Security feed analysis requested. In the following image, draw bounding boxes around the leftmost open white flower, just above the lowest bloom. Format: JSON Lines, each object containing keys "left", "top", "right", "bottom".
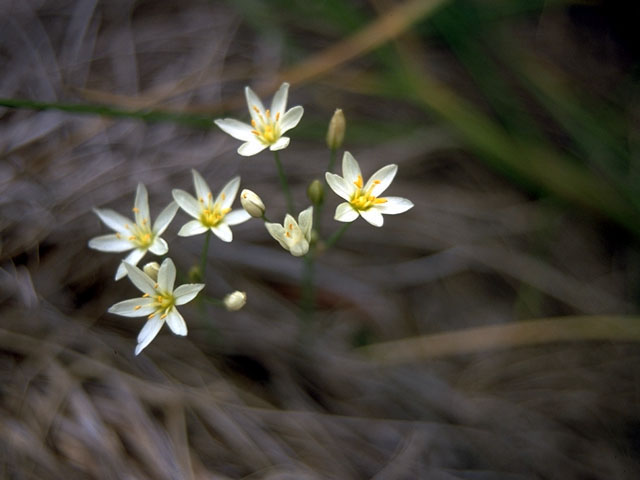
{"left": 89, "top": 183, "right": 178, "bottom": 280}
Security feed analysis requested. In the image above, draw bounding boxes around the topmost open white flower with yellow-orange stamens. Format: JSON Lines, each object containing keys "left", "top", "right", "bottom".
{"left": 215, "top": 83, "right": 304, "bottom": 157}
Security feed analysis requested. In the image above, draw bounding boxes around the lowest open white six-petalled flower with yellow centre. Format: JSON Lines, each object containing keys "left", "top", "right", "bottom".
{"left": 108, "top": 258, "right": 204, "bottom": 355}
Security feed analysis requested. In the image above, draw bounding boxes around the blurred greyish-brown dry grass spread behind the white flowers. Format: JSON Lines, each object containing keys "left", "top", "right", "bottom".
{"left": 0, "top": 0, "right": 640, "bottom": 480}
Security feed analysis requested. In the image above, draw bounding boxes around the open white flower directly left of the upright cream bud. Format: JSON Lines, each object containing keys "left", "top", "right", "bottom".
{"left": 171, "top": 170, "right": 251, "bottom": 242}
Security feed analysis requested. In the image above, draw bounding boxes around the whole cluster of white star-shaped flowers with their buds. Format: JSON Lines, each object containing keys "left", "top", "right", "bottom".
{"left": 89, "top": 79, "right": 413, "bottom": 355}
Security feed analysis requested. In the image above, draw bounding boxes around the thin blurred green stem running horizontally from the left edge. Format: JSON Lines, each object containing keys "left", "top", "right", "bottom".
{"left": 0, "top": 98, "right": 214, "bottom": 128}
